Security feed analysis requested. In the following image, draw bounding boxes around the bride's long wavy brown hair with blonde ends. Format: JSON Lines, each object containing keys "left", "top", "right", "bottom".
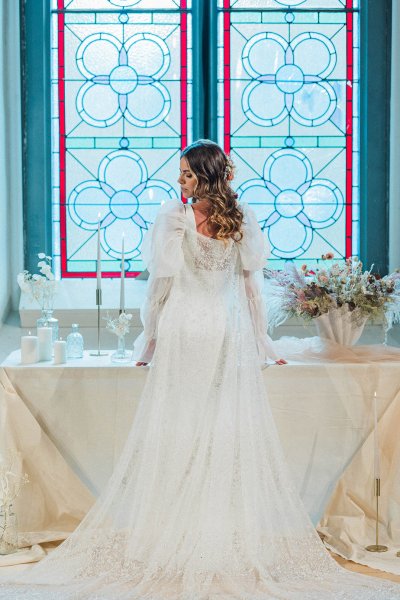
{"left": 181, "top": 140, "right": 243, "bottom": 241}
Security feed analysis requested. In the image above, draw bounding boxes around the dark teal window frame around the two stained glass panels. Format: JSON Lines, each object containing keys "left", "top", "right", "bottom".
{"left": 20, "top": 0, "right": 392, "bottom": 274}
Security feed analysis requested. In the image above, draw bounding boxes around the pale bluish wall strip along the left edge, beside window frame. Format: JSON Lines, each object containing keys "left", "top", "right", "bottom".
{"left": 0, "top": 0, "right": 23, "bottom": 323}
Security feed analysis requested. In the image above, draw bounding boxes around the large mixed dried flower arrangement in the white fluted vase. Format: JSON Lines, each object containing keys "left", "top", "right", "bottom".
{"left": 264, "top": 252, "right": 400, "bottom": 329}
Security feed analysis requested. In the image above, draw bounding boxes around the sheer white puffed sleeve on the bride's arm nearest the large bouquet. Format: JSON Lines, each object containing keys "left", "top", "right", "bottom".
{"left": 239, "top": 204, "right": 278, "bottom": 364}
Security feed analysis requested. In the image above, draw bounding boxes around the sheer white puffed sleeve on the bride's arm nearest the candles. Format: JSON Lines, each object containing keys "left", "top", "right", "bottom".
{"left": 133, "top": 200, "right": 185, "bottom": 363}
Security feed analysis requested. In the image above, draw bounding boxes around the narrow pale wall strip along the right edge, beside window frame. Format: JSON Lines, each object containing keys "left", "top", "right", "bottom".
{"left": 389, "top": 0, "right": 400, "bottom": 272}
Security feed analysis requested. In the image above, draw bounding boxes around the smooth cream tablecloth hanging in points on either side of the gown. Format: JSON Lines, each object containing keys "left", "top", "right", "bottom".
{"left": 2, "top": 344, "right": 400, "bottom": 572}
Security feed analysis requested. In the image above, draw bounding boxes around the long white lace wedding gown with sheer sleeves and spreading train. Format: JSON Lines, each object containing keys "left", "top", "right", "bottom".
{"left": 0, "top": 201, "right": 400, "bottom": 600}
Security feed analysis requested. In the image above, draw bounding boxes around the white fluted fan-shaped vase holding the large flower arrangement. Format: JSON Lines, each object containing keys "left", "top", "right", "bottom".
{"left": 314, "top": 304, "right": 368, "bottom": 346}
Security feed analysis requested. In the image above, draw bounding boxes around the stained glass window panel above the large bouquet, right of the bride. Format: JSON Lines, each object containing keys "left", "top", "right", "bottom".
{"left": 218, "top": 0, "right": 360, "bottom": 267}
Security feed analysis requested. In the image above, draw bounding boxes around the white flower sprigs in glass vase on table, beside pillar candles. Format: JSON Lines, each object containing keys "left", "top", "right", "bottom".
{"left": 17, "top": 252, "right": 57, "bottom": 308}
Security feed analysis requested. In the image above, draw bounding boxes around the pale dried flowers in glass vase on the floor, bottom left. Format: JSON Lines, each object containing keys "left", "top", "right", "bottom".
{"left": 0, "top": 451, "right": 29, "bottom": 554}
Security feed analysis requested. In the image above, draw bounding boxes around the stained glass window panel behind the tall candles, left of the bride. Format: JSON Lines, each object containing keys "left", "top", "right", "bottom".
{"left": 51, "top": 0, "right": 192, "bottom": 277}
